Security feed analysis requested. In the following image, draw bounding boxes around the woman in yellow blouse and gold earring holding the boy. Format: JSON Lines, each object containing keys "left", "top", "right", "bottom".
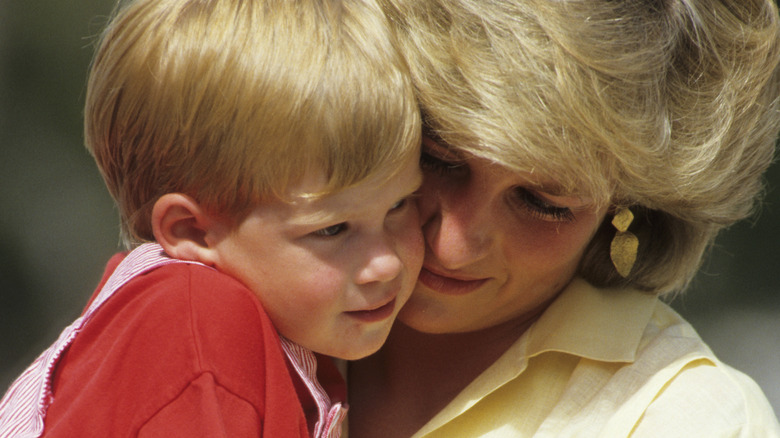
{"left": 349, "top": 0, "right": 780, "bottom": 438}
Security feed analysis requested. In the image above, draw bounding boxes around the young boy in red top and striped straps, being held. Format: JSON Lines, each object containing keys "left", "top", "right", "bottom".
{"left": 0, "top": 0, "right": 423, "bottom": 437}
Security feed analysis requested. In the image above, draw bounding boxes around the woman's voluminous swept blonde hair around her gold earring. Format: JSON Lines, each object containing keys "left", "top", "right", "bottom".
{"left": 383, "top": 0, "right": 780, "bottom": 293}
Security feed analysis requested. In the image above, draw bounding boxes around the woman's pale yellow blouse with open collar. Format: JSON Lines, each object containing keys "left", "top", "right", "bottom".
{"left": 414, "top": 280, "right": 780, "bottom": 438}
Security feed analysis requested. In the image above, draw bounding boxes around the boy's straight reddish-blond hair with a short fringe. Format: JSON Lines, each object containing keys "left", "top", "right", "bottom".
{"left": 85, "top": 0, "right": 420, "bottom": 243}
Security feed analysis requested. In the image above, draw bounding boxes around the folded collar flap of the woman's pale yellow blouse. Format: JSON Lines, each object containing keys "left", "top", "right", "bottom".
{"left": 526, "top": 278, "right": 657, "bottom": 362}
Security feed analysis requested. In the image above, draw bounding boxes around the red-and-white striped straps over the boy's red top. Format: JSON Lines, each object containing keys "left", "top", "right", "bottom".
{"left": 0, "top": 243, "right": 346, "bottom": 438}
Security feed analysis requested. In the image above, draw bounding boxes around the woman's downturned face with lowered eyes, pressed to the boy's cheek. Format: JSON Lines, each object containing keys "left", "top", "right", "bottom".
{"left": 399, "top": 137, "right": 606, "bottom": 333}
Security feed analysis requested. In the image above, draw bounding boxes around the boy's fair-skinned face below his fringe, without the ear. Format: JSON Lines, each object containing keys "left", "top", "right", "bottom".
{"left": 210, "top": 157, "right": 423, "bottom": 359}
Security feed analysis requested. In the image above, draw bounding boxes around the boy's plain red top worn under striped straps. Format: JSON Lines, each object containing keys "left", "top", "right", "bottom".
{"left": 39, "top": 252, "right": 332, "bottom": 438}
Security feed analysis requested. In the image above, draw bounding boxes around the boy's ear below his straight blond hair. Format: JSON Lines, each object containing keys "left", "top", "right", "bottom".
{"left": 152, "top": 193, "right": 224, "bottom": 266}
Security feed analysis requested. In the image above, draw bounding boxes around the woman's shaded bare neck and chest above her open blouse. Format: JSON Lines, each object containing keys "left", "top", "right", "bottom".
{"left": 349, "top": 318, "right": 536, "bottom": 438}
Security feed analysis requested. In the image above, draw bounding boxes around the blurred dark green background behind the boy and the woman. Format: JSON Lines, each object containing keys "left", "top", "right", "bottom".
{"left": 0, "top": 0, "right": 780, "bottom": 414}
